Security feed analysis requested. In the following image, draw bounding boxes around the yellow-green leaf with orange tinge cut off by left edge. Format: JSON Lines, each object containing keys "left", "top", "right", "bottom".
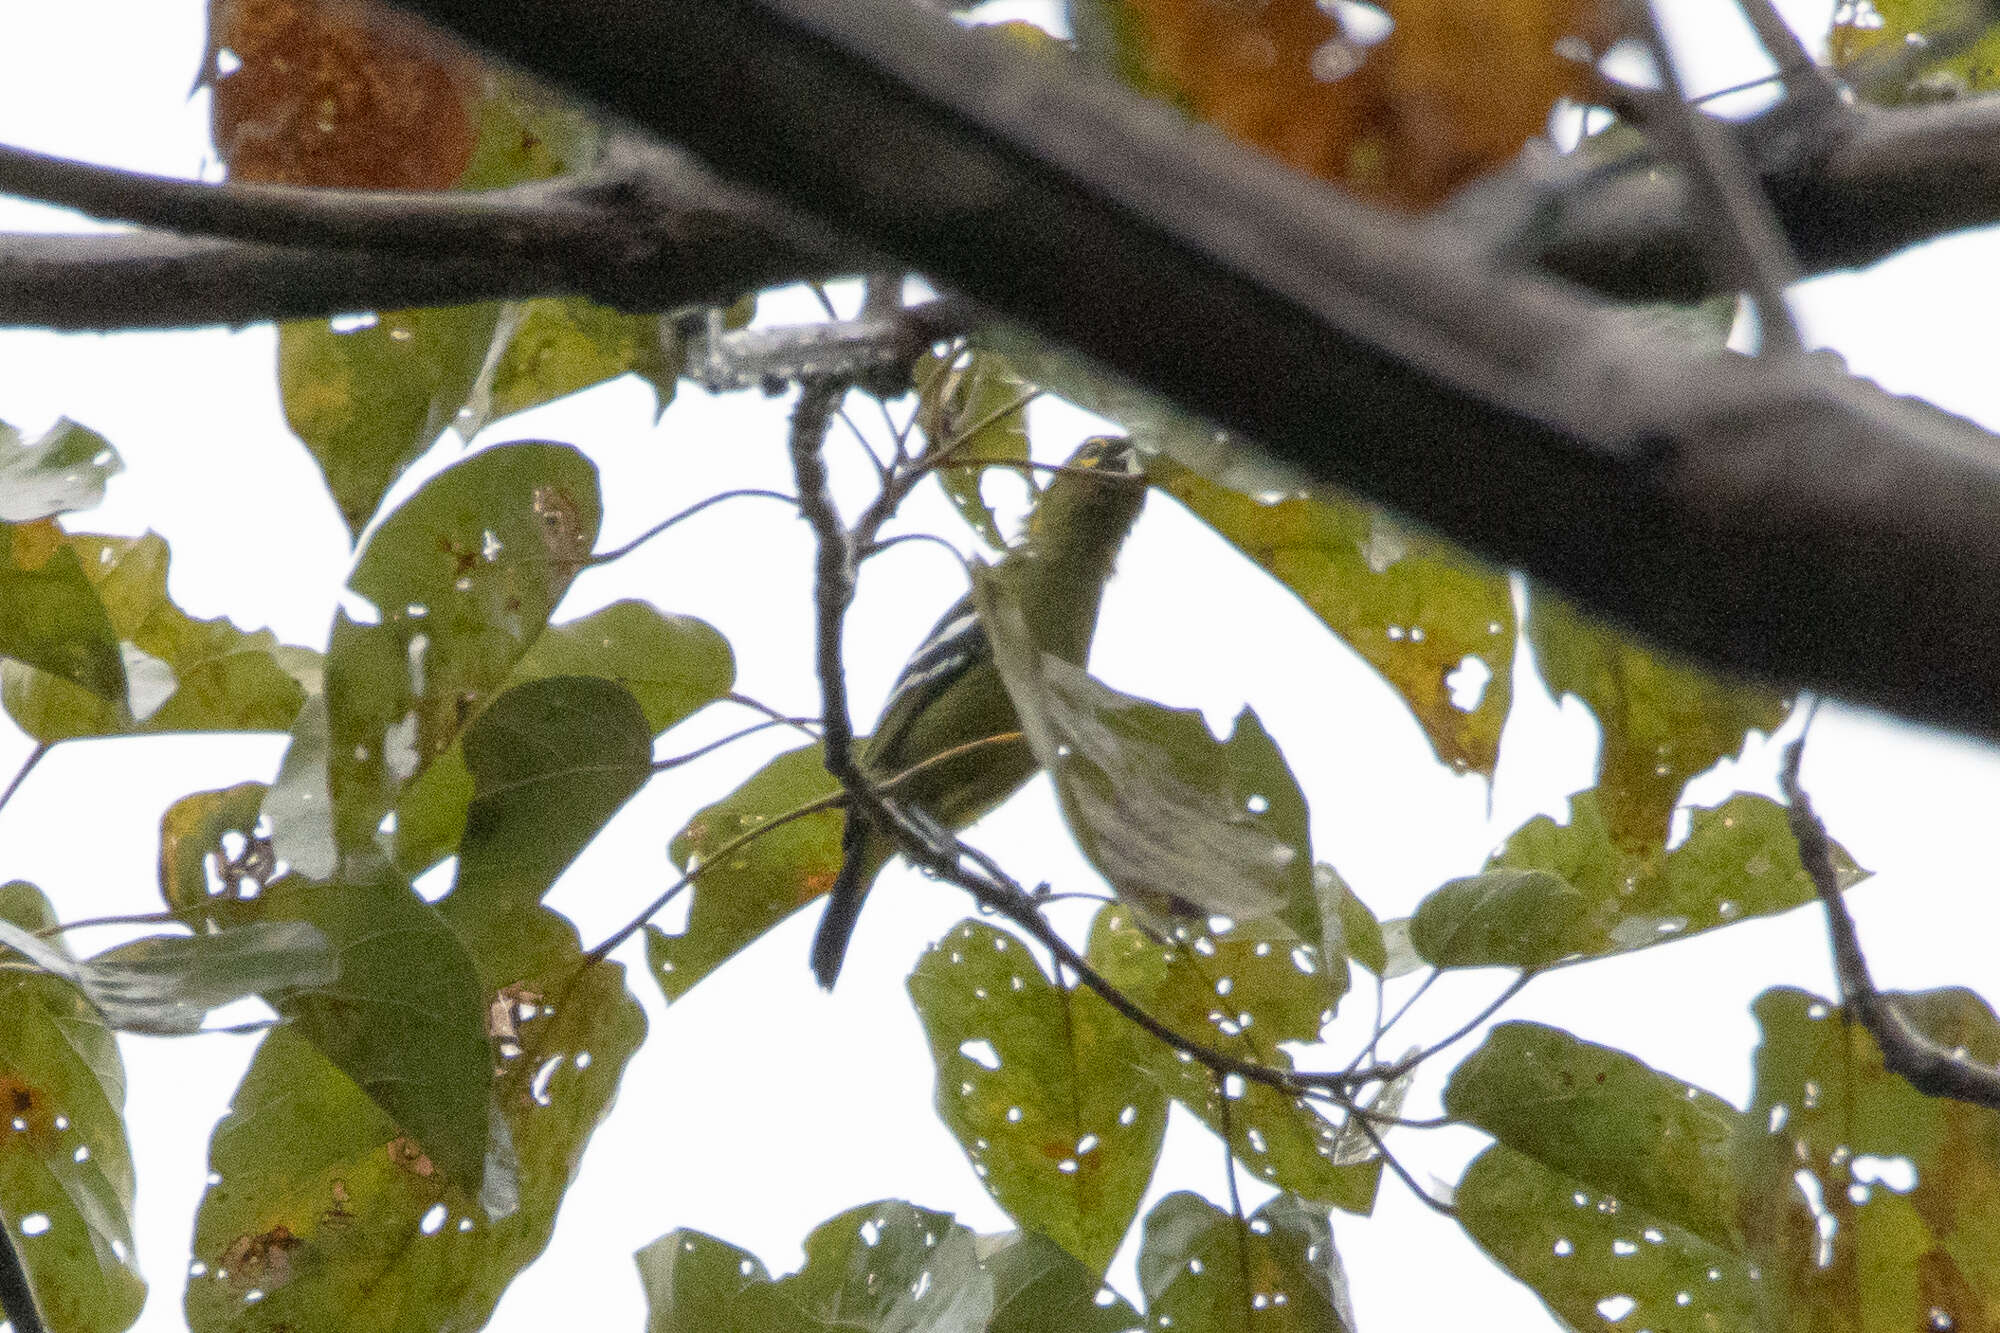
{"left": 0, "top": 522, "right": 126, "bottom": 713}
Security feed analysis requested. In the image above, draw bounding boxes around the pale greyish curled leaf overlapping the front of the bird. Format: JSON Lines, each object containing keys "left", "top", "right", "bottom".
{"left": 972, "top": 568, "right": 1288, "bottom": 924}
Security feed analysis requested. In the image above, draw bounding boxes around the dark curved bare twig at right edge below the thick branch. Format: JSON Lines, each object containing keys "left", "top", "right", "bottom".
{"left": 1778, "top": 737, "right": 2000, "bottom": 1109}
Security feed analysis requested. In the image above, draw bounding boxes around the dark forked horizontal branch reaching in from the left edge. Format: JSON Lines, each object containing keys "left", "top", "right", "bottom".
{"left": 0, "top": 140, "right": 852, "bottom": 330}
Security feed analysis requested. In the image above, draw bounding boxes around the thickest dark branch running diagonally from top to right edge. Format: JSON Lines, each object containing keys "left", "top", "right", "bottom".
{"left": 364, "top": 0, "right": 2000, "bottom": 748}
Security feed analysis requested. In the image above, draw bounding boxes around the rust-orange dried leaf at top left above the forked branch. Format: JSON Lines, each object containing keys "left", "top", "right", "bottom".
{"left": 208, "top": 0, "right": 478, "bottom": 190}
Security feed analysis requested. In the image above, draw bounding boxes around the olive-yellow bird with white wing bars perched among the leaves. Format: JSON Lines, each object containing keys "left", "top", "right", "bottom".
{"left": 812, "top": 436, "right": 1146, "bottom": 991}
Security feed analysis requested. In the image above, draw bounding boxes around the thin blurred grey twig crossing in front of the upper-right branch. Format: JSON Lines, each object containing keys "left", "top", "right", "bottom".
{"left": 1628, "top": 0, "right": 1804, "bottom": 354}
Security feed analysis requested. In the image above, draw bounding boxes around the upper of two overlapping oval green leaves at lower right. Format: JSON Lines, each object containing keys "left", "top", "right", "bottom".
{"left": 1444, "top": 1023, "right": 1744, "bottom": 1247}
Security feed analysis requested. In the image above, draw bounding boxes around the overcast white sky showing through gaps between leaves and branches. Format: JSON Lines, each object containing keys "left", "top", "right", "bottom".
{"left": 19, "top": 0, "right": 2000, "bottom": 1331}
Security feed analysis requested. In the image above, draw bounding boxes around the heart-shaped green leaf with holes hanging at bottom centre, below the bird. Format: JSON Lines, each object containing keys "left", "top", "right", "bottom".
{"left": 910, "top": 921, "right": 1166, "bottom": 1264}
